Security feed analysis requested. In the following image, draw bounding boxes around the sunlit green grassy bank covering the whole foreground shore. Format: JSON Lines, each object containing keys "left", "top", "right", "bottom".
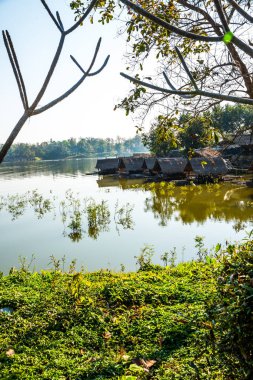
{"left": 0, "top": 239, "right": 253, "bottom": 380}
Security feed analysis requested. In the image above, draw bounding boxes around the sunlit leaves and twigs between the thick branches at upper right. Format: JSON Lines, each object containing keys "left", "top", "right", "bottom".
{"left": 67, "top": 0, "right": 251, "bottom": 126}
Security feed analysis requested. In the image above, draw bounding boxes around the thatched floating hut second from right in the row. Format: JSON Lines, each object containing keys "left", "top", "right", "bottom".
{"left": 153, "top": 157, "right": 188, "bottom": 178}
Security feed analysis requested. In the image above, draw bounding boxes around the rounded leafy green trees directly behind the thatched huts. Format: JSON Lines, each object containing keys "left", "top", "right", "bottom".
{"left": 142, "top": 104, "right": 253, "bottom": 156}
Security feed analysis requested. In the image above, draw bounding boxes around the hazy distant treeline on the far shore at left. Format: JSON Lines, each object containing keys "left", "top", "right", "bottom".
{"left": 1, "top": 136, "right": 147, "bottom": 161}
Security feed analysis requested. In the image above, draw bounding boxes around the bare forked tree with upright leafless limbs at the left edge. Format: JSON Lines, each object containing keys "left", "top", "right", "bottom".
{"left": 0, "top": 0, "right": 109, "bottom": 163}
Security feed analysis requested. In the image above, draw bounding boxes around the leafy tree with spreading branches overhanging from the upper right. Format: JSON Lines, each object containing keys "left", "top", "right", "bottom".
{"left": 71, "top": 0, "right": 253, "bottom": 121}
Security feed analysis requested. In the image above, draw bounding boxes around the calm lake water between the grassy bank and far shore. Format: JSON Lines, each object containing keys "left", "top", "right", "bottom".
{"left": 0, "top": 159, "right": 253, "bottom": 273}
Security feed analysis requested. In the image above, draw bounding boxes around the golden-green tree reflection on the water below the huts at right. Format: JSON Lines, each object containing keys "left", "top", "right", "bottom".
{"left": 144, "top": 184, "right": 253, "bottom": 230}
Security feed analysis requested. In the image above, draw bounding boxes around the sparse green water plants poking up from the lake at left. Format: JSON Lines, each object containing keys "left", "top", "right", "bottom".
{"left": 0, "top": 190, "right": 134, "bottom": 242}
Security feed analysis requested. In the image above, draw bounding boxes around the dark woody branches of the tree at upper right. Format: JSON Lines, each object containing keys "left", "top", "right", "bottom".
{"left": 120, "top": 0, "right": 253, "bottom": 116}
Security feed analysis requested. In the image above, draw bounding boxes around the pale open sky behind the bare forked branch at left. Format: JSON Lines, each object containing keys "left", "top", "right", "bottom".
{"left": 0, "top": 0, "right": 138, "bottom": 143}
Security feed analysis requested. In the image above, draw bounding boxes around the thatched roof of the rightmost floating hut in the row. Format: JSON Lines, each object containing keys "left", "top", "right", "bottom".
{"left": 190, "top": 157, "right": 228, "bottom": 175}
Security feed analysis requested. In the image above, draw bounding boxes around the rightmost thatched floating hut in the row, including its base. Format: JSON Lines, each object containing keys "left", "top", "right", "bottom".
{"left": 186, "top": 157, "right": 228, "bottom": 180}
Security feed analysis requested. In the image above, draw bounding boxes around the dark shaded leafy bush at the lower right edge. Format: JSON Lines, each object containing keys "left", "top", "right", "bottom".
{"left": 209, "top": 233, "right": 253, "bottom": 379}
